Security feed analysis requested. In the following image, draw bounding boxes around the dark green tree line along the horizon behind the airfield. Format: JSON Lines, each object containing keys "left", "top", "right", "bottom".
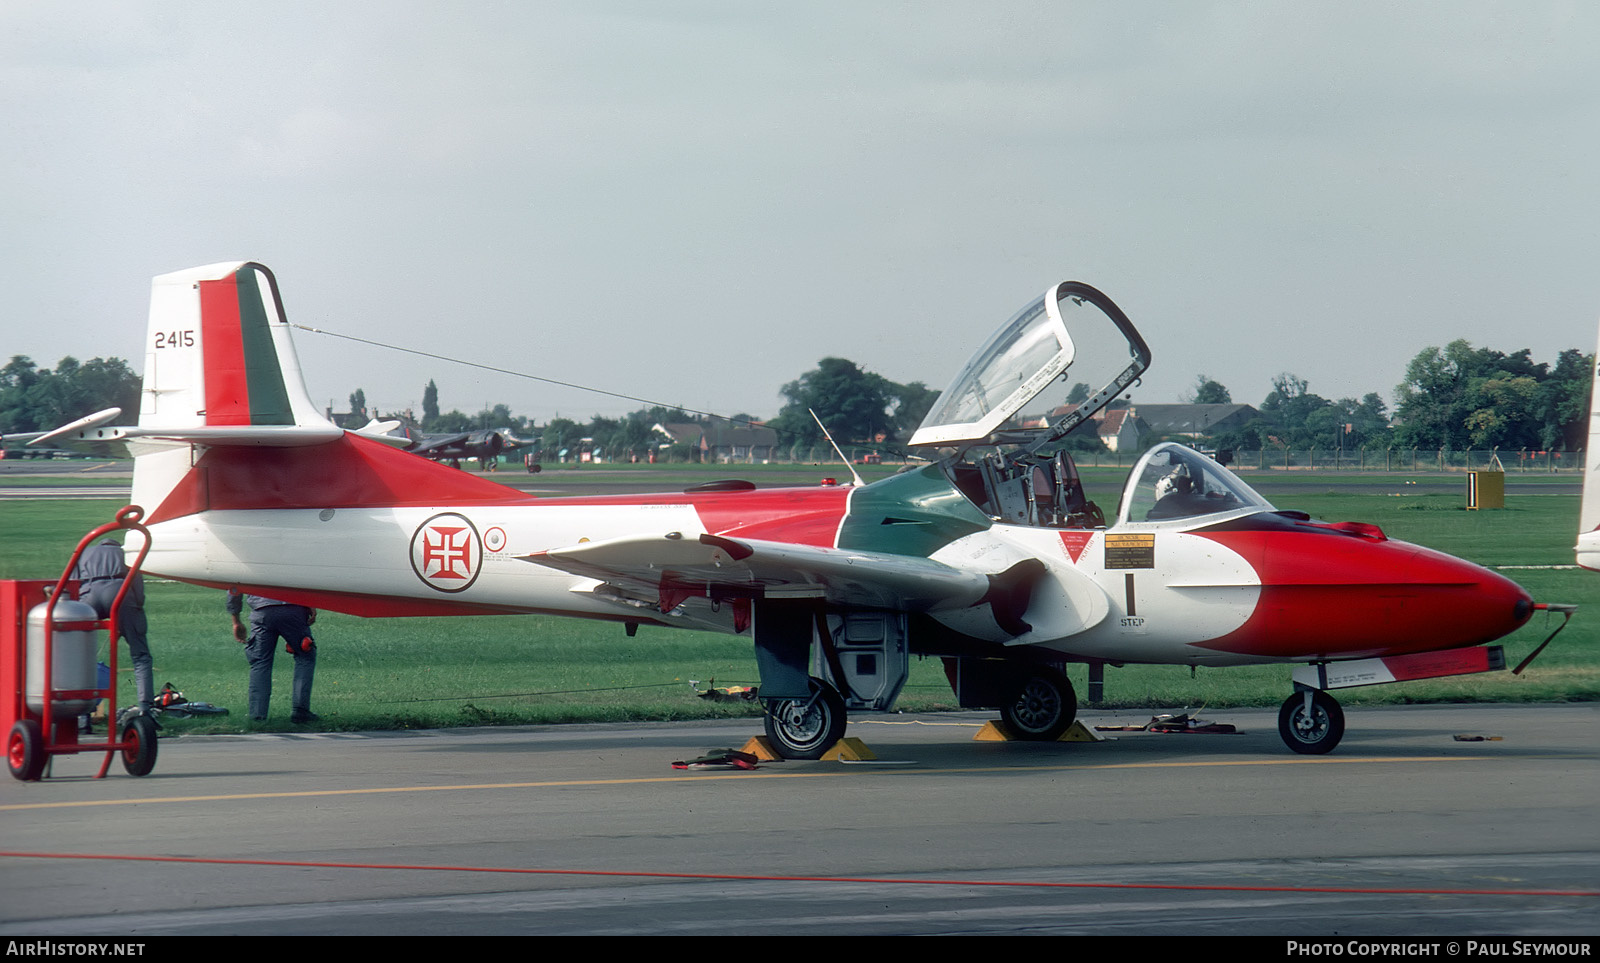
{"left": 0, "top": 339, "right": 1595, "bottom": 454}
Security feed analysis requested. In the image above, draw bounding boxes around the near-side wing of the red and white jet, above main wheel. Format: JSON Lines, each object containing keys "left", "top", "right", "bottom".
{"left": 522, "top": 533, "right": 998, "bottom": 611}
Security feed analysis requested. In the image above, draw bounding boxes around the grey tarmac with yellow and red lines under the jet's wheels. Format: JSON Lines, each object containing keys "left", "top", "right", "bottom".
{"left": 0, "top": 704, "right": 1600, "bottom": 937}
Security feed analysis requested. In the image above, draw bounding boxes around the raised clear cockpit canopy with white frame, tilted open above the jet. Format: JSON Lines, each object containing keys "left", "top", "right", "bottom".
{"left": 910, "top": 282, "right": 1150, "bottom": 451}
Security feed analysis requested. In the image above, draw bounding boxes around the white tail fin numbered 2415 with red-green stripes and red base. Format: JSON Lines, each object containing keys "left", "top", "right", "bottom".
{"left": 129, "top": 261, "right": 525, "bottom": 531}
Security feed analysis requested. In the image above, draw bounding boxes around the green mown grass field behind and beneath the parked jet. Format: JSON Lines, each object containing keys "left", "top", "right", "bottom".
{"left": 0, "top": 476, "right": 1600, "bottom": 733}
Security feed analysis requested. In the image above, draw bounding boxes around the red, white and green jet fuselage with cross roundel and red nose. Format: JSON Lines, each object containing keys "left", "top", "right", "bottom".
{"left": 146, "top": 437, "right": 1531, "bottom": 665}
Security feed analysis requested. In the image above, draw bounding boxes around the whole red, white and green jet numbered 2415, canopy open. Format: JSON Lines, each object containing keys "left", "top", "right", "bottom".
{"left": 65, "top": 262, "right": 1534, "bottom": 758}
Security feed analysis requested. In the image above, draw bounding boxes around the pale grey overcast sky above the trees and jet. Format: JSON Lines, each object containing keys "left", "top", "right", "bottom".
{"left": 0, "top": 0, "right": 1600, "bottom": 427}
